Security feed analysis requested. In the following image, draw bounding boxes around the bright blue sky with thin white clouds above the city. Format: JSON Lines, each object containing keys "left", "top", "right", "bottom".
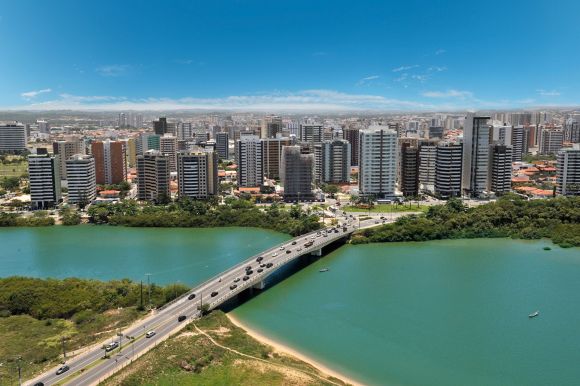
{"left": 0, "top": 0, "right": 580, "bottom": 111}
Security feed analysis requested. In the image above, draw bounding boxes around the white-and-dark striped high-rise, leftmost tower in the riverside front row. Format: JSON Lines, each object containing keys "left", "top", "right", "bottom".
{"left": 28, "top": 154, "right": 62, "bottom": 209}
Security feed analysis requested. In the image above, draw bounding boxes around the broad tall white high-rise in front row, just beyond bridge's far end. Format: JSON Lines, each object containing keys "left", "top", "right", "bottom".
{"left": 358, "top": 126, "right": 397, "bottom": 199}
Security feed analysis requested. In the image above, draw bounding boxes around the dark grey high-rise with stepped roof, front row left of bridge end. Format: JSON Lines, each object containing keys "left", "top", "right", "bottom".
{"left": 280, "top": 146, "right": 314, "bottom": 202}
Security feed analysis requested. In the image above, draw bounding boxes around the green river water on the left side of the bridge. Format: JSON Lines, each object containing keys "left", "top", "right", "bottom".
{"left": 0, "top": 225, "right": 290, "bottom": 285}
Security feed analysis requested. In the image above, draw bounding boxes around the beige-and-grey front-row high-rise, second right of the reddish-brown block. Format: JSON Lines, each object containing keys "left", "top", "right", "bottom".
{"left": 177, "top": 148, "right": 218, "bottom": 199}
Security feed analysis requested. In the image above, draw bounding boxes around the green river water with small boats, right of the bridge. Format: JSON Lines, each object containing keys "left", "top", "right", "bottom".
{"left": 233, "top": 240, "right": 580, "bottom": 386}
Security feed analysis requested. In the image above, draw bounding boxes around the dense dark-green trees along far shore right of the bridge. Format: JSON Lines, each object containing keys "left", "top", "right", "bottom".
{"left": 351, "top": 194, "right": 580, "bottom": 248}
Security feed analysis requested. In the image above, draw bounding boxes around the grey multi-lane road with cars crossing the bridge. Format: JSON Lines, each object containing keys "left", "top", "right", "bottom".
{"left": 25, "top": 214, "right": 390, "bottom": 386}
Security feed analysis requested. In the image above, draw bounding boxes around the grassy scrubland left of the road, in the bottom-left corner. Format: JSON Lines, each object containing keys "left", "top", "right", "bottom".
{"left": 0, "top": 308, "right": 141, "bottom": 386}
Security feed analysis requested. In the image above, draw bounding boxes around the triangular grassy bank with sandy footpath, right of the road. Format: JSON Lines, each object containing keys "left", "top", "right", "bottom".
{"left": 103, "top": 311, "right": 343, "bottom": 386}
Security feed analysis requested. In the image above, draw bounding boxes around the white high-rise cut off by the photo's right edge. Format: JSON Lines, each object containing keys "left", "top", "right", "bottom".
{"left": 556, "top": 144, "right": 580, "bottom": 196}
